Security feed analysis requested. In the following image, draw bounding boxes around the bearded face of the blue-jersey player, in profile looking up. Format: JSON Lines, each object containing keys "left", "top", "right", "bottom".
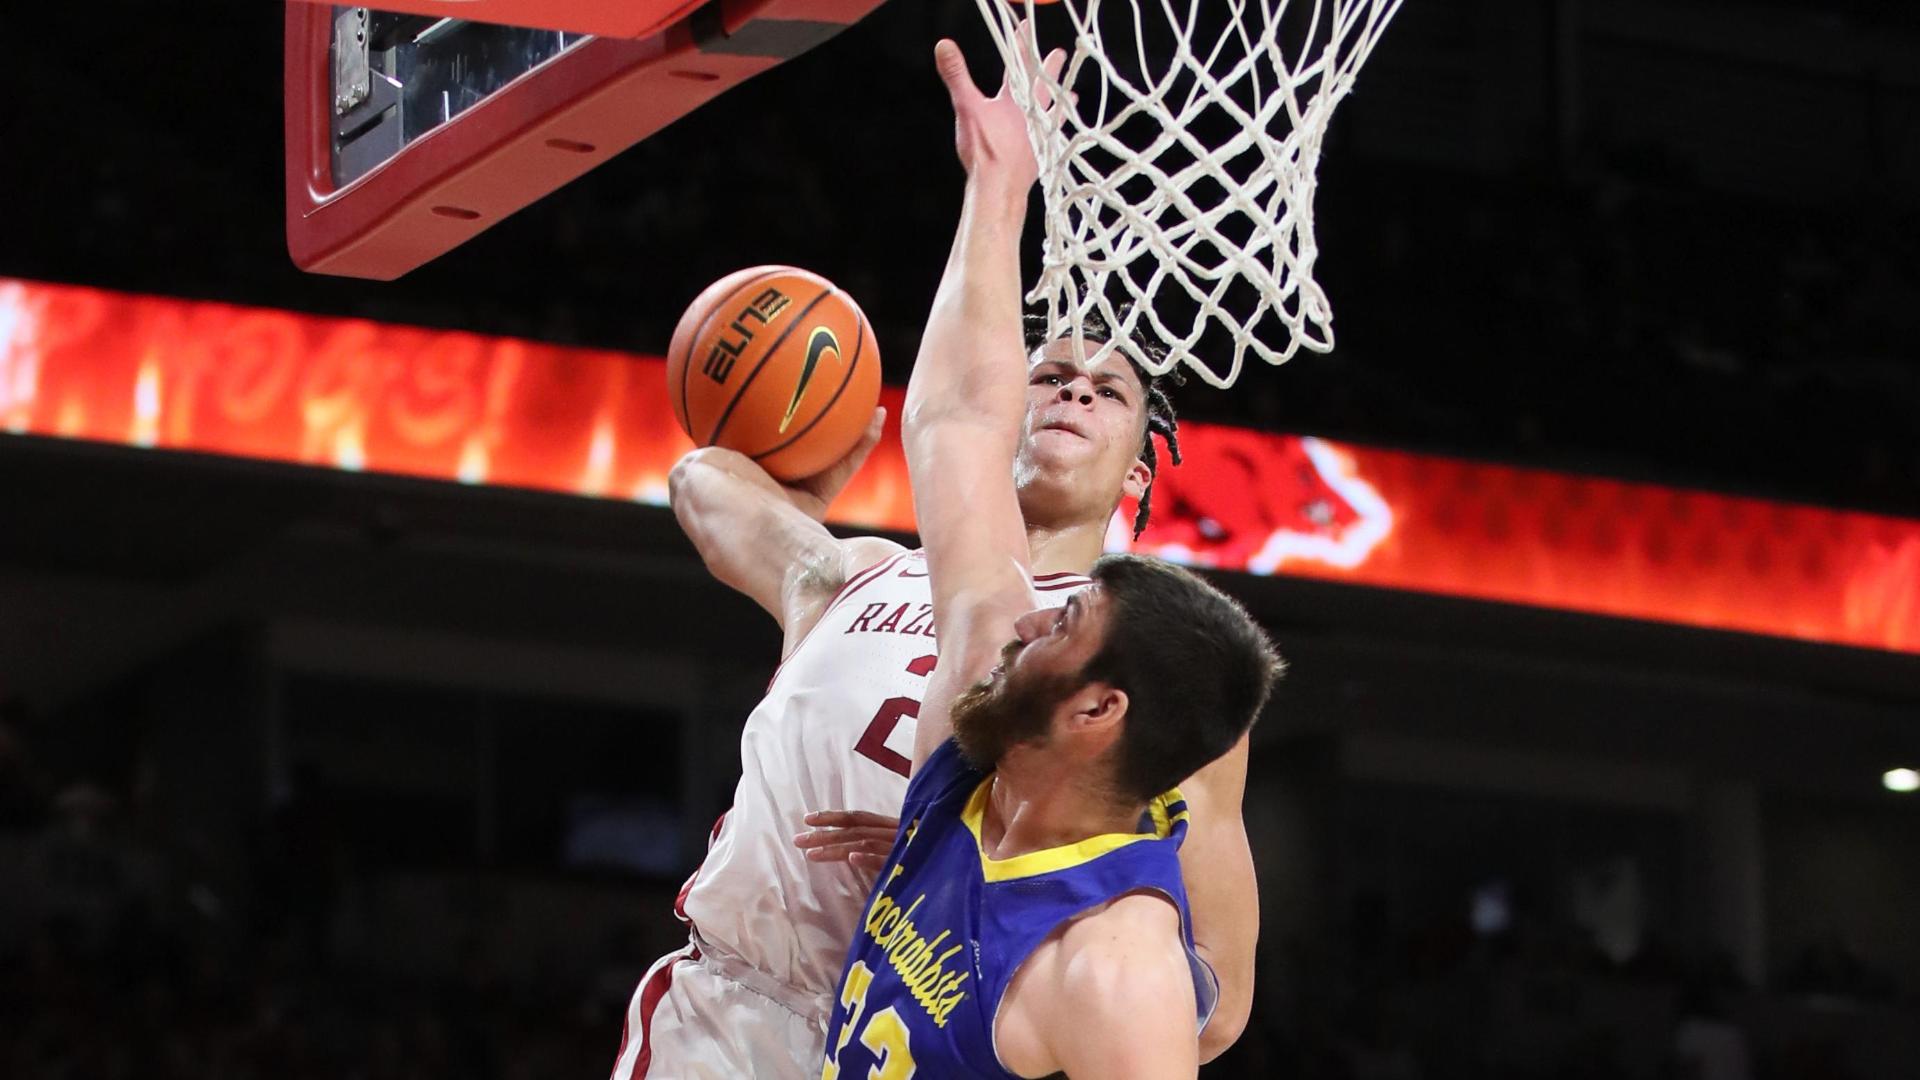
{"left": 952, "top": 584, "right": 1106, "bottom": 769}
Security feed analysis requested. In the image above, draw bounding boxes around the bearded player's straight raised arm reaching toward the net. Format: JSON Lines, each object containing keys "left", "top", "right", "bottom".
{"left": 904, "top": 40, "right": 1058, "bottom": 765}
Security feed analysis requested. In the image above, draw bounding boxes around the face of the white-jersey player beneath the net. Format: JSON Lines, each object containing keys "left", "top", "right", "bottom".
{"left": 1014, "top": 340, "right": 1146, "bottom": 521}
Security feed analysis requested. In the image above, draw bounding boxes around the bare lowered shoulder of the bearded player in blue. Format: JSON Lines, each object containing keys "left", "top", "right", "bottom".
{"left": 1029, "top": 894, "right": 1200, "bottom": 1080}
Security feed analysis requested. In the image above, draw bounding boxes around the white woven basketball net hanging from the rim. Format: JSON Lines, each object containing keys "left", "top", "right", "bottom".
{"left": 977, "top": 0, "right": 1400, "bottom": 388}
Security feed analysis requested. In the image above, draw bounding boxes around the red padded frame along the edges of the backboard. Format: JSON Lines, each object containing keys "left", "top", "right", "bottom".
{"left": 284, "top": 0, "right": 883, "bottom": 281}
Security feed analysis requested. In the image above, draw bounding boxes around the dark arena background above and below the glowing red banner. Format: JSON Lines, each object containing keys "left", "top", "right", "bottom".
{"left": 0, "top": 0, "right": 1920, "bottom": 1080}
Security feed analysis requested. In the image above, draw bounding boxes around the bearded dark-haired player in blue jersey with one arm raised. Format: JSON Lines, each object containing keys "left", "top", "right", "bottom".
{"left": 824, "top": 42, "right": 1281, "bottom": 1080}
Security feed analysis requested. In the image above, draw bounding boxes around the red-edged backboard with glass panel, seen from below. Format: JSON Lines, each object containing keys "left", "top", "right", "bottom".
{"left": 284, "top": 0, "right": 883, "bottom": 281}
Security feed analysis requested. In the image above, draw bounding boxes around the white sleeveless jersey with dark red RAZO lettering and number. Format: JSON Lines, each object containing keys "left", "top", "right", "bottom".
{"left": 678, "top": 552, "right": 1089, "bottom": 1024}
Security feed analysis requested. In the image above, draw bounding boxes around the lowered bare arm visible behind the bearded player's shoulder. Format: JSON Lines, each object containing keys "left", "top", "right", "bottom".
{"left": 1181, "top": 736, "right": 1260, "bottom": 1061}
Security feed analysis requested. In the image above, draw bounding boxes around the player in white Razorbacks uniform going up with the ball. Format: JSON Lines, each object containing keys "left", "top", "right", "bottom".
{"left": 612, "top": 46, "right": 1258, "bottom": 1080}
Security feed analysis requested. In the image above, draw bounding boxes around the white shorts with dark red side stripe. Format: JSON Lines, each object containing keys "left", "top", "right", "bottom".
{"left": 612, "top": 944, "right": 828, "bottom": 1080}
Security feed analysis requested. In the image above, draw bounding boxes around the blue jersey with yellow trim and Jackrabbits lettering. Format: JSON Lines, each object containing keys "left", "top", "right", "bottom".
{"left": 822, "top": 740, "right": 1219, "bottom": 1080}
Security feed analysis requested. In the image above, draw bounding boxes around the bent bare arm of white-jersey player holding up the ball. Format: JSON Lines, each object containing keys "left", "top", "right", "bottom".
{"left": 668, "top": 409, "right": 899, "bottom": 653}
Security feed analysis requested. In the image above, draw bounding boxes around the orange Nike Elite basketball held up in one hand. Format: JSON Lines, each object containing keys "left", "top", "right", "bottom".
{"left": 666, "top": 267, "right": 879, "bottom": 480}
